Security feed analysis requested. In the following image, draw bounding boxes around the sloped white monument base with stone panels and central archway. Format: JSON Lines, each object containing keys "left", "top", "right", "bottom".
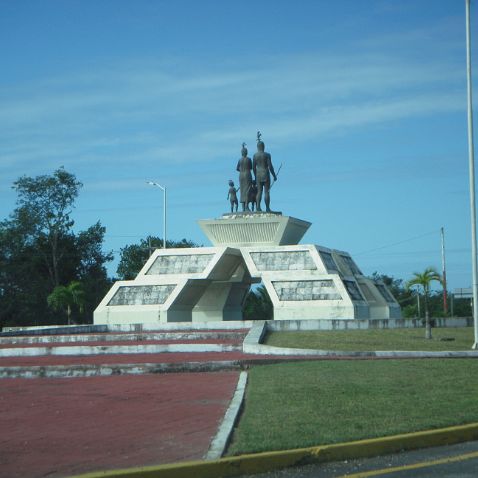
{"left": 94, "top": 245, "right": 401, "bottom": 324}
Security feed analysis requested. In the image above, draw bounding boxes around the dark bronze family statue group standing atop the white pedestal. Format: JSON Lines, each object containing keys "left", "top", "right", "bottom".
{"left": 227, "top": 131, "right": 277, "bottom": 213}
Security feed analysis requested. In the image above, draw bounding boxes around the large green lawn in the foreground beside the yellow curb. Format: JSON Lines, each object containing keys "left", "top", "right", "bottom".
{"left": 228, "top": 359, "right": 478, "bottom": 455}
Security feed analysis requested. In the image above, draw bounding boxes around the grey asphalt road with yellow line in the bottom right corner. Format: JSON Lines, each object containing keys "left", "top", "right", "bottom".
{"left": 242, "top": 441, "right": 478, "bottom": 478}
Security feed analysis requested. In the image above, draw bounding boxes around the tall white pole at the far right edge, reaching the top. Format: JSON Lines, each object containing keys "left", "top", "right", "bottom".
{"left": 465, "top": 0, "right": 478, "bottom": 349}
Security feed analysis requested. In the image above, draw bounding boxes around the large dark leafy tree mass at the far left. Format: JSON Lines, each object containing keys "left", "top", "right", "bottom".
{"left": 0, "top": 168, "right": 112, "bottom": 326}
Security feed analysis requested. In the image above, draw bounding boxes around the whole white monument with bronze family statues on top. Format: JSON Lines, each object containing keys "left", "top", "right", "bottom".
{"left": 94, "top": 132, "right": 401, "bottom": 324}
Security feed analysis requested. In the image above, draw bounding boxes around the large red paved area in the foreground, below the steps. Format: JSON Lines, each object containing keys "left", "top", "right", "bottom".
{"left": 0, "top": 372, "right": 239, "bottom": 478}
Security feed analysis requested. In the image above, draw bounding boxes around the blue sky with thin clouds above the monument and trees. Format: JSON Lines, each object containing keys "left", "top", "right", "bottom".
{"left": 0, "top": 0, "right": 478, "bottom": 288}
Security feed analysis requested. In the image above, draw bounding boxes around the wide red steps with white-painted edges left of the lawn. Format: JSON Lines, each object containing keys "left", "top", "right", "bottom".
{"left": 0, "top": 324, "right": 258, "bottom": 378}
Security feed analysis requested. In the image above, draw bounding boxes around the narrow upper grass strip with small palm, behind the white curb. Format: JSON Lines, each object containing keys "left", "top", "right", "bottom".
{"left": 265, "top": 327, "right": 474, "bottom": 351}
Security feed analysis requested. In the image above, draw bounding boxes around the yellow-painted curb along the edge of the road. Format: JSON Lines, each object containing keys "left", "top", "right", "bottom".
{"left": 70, "top": 423, "right": 478, "bottom": 478}
